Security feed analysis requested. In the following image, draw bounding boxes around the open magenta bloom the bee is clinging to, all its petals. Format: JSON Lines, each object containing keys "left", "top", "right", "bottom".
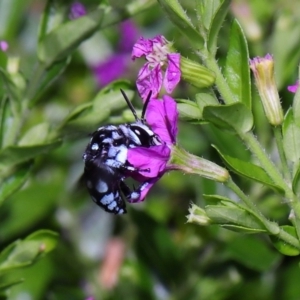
{"left": 127, "top": 95, "right": 178, "bottom": 202}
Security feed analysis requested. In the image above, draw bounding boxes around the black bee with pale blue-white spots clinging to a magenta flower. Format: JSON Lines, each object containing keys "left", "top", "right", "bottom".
{"left": 83, "top": 90, "right": 162, "bottom": 214}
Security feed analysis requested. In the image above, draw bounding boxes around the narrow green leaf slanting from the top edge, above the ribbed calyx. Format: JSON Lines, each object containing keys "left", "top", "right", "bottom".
{"left": 158, "top": 0, "right": 204, "bottom": 50}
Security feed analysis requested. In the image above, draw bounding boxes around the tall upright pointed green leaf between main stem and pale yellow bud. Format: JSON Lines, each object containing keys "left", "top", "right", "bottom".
{"left": 224, "top": 20, "right": 251, "bottom": 110}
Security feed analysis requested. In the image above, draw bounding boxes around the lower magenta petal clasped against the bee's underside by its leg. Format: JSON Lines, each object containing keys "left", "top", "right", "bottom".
{"left": 127, "top": 145, "right": 171, "bottom": 181}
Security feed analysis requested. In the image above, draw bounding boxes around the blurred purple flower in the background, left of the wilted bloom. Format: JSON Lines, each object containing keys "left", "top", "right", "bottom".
{"left": 92, "top": 20, "right": 138, "bottom": 86}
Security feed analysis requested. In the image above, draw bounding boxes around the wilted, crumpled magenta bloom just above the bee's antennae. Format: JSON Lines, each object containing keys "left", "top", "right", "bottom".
{"left": 132, "top": 35, "right": 181, "bottom": 101}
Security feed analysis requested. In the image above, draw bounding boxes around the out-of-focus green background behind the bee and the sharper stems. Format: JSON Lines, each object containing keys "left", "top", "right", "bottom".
{"left": 0, "top": 0, "right": 300, "bottom": 300}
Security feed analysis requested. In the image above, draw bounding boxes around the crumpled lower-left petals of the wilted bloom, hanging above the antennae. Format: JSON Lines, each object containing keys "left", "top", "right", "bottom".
{"left": 136, "top": 63, "right": 163, "bottom": 101}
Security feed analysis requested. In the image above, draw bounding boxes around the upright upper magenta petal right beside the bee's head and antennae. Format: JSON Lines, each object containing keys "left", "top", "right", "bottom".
{"left": 146, "top": 95, "right": 178, "bottom": 144}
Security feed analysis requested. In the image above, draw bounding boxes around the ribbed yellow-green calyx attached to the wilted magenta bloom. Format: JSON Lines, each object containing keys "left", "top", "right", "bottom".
{"left": 180, "top": 56, "right": 215, "bottom": 88}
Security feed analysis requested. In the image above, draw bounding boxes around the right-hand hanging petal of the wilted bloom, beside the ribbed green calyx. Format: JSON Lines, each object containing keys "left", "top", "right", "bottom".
{"left": 163, "top": 53, "right": 181, "bottom": 94}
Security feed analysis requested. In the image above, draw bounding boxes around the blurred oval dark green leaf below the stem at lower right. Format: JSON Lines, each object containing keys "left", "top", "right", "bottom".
{"left": 226, "top": 236, "right": 280, "bottom": 272}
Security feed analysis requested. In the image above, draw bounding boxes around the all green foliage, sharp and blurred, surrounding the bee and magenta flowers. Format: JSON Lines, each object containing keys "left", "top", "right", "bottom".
{"left": 0, "top": 0, "right": 300, "bottom": 300}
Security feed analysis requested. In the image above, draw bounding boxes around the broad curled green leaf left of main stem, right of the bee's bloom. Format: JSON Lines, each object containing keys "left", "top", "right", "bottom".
{"left": 203, "top": 102, "right": 253, "bottom": 133}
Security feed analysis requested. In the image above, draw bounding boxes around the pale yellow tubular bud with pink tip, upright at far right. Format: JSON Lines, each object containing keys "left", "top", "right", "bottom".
{"left": 250, "top": 54, "right": 283, "bottom": 126}
